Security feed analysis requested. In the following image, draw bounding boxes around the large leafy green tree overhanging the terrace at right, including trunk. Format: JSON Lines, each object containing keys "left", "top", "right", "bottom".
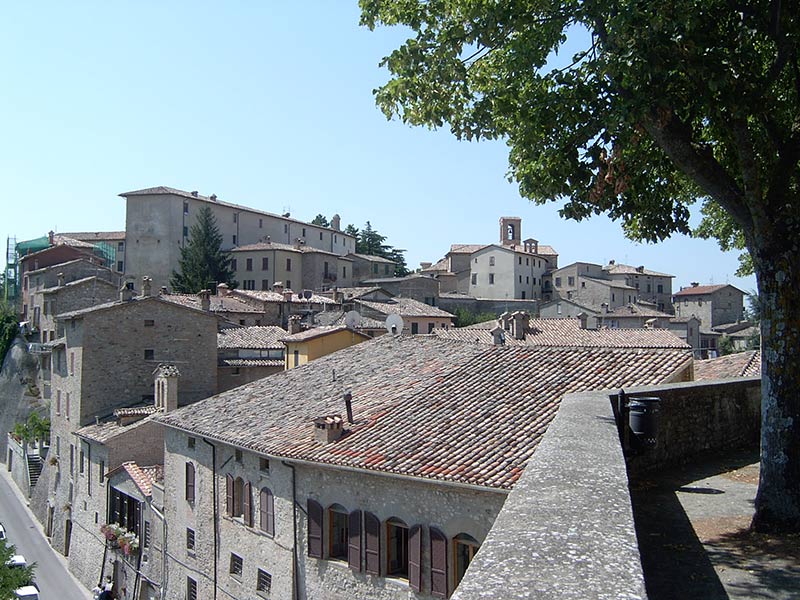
{"left": 360, "top": 0, "right": 800, "bottom": 531}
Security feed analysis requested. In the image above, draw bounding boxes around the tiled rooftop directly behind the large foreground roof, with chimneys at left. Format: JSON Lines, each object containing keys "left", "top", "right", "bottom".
{"left": 433, "top": 319, "right": 689, "bottom": 349}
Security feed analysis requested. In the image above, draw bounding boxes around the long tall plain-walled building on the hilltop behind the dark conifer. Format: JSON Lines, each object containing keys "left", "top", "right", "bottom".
{"left": 120, "top": 186, "right": 355, "bottom": 287}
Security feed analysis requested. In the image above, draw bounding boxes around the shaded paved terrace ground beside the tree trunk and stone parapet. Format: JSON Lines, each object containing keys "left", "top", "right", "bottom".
{"left": 631, "top": 450, "right": 800, "bottom": 600}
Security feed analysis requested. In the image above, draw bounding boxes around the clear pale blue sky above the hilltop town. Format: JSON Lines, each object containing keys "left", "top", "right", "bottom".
{"left": 0, "top": 0, "right": 755, "bottom": 291}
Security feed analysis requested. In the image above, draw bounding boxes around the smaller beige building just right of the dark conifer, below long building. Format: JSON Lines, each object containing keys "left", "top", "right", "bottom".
{"left": 231, "top": 238, "right": 353, "bottom": 292}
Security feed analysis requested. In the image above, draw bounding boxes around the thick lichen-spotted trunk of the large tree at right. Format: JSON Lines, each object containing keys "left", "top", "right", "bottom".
{"left": 752, "top": 241, "right": 800, "bottom": 533}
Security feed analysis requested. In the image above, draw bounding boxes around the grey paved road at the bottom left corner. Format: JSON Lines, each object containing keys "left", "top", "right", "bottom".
{"left": 0, "top": 464, "right": 92, "bottom": 600}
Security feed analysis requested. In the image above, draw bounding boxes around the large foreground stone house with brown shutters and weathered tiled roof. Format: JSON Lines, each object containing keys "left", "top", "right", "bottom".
{"left": 158, "top": 335, "right": 692, "bottom": 600}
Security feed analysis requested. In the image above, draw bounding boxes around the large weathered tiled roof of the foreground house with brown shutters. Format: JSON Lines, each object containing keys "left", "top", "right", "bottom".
{"left": 158, "top": 335, "right": 691, "bottom": 489}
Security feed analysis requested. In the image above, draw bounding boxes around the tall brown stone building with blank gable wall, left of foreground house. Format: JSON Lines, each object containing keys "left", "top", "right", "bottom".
{"left": 37, "top": 281, "right": 217, "bottom": 554}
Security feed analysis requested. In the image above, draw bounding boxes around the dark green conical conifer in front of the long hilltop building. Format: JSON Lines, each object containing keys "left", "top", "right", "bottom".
{"left": 170, "top": 206, "right": 236, "bottom": 294}
